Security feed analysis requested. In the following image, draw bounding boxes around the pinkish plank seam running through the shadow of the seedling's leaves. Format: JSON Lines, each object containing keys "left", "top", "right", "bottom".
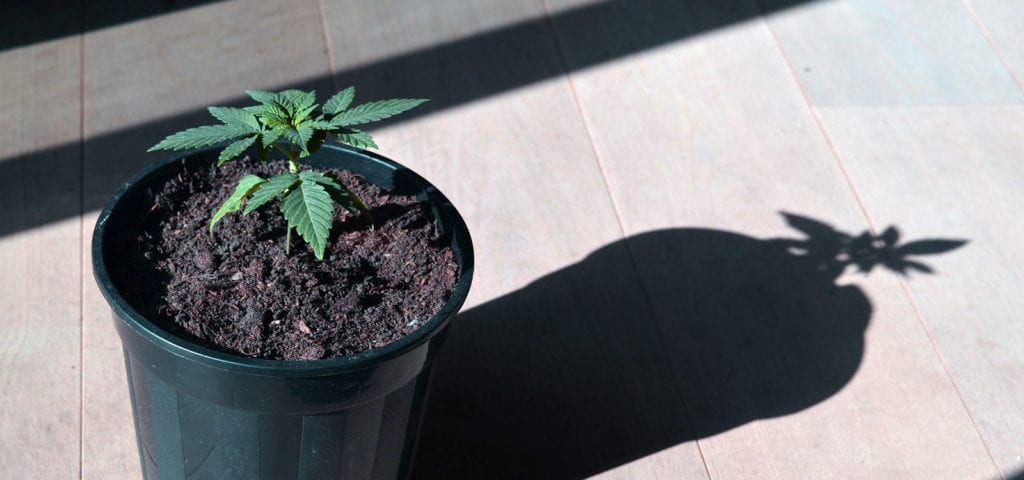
{"left": 755, "top": 1, "right": 1006, "bottom": 474}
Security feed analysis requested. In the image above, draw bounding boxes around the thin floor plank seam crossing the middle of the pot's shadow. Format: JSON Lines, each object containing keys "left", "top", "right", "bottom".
{"left": 541, "top": 0, "right": 712, "bottom": 480}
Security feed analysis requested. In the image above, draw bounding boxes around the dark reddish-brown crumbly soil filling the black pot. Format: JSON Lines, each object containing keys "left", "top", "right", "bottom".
{"left": 115, "top": 159, "right": 458, "bottom": 360}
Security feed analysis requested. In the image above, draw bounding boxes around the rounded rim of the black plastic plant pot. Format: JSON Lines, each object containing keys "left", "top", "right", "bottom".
{"left": 91, "top": 143, "right": 474, "bottom": 377}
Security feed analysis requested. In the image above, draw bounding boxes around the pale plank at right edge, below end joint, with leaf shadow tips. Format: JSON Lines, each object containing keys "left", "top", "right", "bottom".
{"left": 822, "top": 105, "right": 1024, "bottom": 474}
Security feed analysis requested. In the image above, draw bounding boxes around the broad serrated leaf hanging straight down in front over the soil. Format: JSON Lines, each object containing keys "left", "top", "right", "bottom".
{"left": 281, "top": 181, "right": 334, "bottom": 260}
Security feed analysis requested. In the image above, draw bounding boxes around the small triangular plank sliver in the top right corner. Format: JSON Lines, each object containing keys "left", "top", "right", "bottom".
{"left": 964, "top": 0, "right": 1024, "bottom": 88}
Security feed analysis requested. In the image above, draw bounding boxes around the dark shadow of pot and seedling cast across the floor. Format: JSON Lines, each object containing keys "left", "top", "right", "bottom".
{"left": 414, "top": 213, "right": 966, "bottom": 479}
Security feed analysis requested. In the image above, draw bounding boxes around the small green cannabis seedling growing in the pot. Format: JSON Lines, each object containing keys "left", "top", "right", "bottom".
{"left": 148, "top": 87, "right": 427, "bottom": 260}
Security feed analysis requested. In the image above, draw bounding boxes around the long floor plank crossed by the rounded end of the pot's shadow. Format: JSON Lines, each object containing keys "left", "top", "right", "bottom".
{"left": 555, "top": 2, "right": 995, "bottom": 472}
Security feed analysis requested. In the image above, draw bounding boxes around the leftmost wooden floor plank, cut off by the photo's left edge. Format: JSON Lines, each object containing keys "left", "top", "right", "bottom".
{"left": 0, "top": 38, "right": 82, "bottom": 478}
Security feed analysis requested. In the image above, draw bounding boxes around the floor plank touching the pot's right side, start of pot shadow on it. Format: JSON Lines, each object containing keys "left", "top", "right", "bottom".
{"left": 325, "top": 1, "right": 703, "bottom": 478}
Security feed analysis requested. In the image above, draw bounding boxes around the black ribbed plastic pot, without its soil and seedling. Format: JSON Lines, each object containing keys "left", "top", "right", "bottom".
{"left": 92, "top": 144, "right": 473, "bottom": 480}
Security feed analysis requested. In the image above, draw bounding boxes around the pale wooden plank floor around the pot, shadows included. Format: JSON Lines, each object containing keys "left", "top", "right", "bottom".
{"left": 0, "top": 0, "right": 1024, "bottom": 480}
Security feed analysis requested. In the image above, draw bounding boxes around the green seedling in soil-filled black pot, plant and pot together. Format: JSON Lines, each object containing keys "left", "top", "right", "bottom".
{"left": 92, "top": 87, "right": 473, "bottom": 479}
